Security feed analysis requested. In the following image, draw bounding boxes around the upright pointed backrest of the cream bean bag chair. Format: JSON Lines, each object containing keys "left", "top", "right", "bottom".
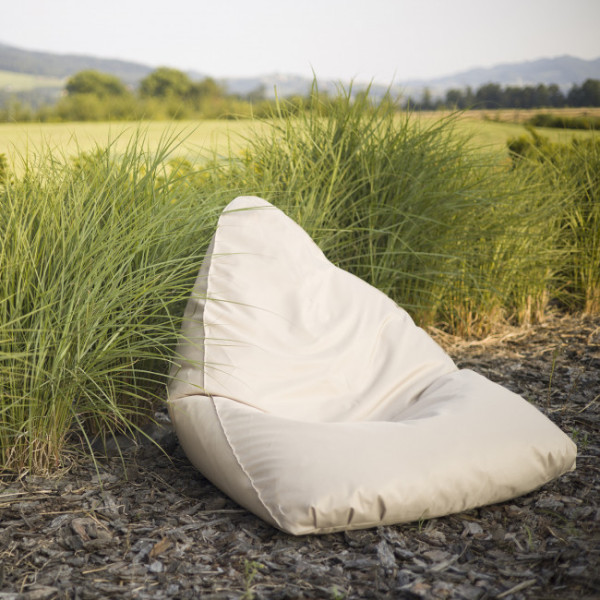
{"left": 170, "top": 197, "right": 456, "bottom": 421}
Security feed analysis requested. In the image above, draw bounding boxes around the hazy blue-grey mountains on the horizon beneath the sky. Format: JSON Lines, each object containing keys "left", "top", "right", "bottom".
{"left": 0, "top": 43, "right": 600, "bottom": 98}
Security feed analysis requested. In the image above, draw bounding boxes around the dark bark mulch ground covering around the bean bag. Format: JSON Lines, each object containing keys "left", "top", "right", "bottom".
{"left": 0, "top": 314, "right": 600, "bottom": 600}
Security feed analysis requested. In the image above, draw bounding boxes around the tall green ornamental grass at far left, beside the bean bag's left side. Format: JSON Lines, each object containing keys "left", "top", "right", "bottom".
{"left": 0, "top": 135, "right": 218, "bottom": 471}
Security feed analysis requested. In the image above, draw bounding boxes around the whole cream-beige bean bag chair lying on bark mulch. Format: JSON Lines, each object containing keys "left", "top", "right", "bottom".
{"left": 169, "top": 197, "right": 576, "bottom": 534}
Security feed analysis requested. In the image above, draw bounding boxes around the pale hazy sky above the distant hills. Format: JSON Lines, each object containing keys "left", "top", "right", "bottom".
{"left": 0, "top": 0, "right": 600, "bottom": 83}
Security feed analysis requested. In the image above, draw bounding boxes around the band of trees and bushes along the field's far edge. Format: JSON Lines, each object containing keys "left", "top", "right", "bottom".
{"left": 0, "top": 67, "right": 600, "bottom": 122}
